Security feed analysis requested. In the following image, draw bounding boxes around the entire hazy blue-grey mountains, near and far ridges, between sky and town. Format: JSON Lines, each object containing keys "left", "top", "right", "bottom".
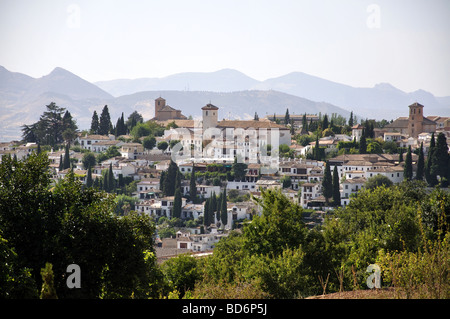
{"left": 0, "top": 66, "right": 450, "bottom": 141}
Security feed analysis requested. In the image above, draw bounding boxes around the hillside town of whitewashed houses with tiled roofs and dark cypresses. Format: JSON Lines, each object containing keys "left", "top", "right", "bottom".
{"left": 0, "top": 97, "right": 450, "bottom": 260}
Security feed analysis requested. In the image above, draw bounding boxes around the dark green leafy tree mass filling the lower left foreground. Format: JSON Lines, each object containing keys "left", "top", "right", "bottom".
{"left": 0, "top": 154, "right": 164, "bottom": 298}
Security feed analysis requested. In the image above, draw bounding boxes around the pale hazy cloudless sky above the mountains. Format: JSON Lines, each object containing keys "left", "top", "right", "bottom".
{"left": 0, "top": 0, "right": 450, "bottom": 96}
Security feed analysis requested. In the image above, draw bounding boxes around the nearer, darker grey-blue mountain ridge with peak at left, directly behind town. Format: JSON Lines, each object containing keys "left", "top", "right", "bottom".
{"left": 0, "top": 68, "right": 350, "bottom": 141}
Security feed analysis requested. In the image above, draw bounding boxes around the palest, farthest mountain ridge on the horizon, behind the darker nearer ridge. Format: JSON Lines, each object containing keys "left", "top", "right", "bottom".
{"left": 95, "top": 69, "right": 450, "bottom": 120}
